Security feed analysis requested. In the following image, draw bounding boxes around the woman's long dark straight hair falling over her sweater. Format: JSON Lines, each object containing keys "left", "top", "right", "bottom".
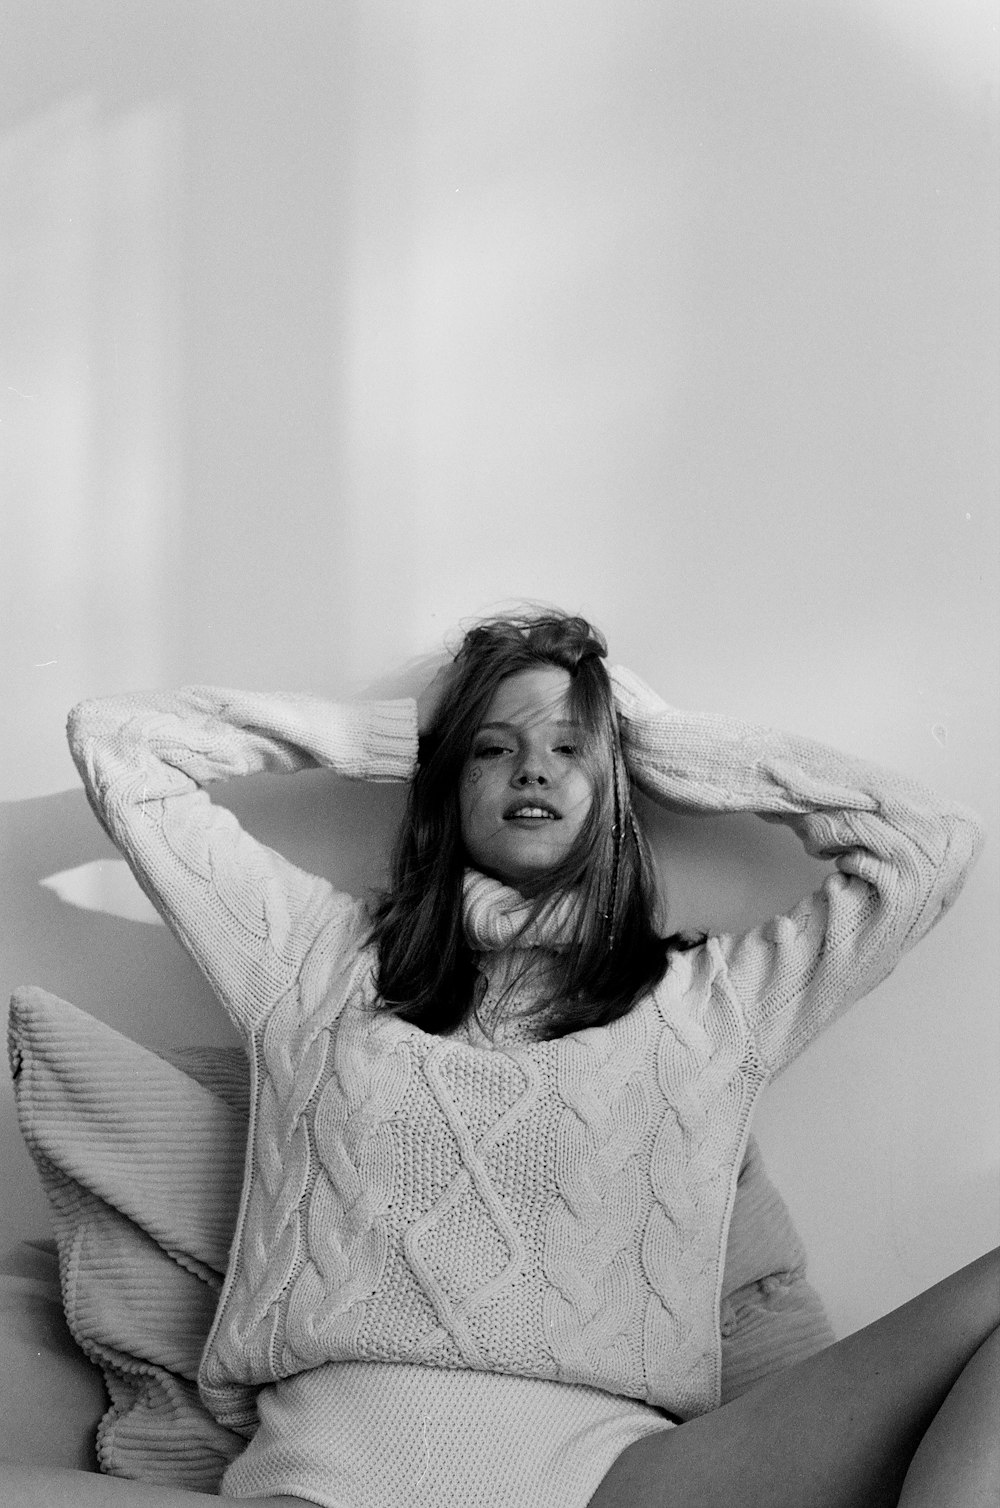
{"left": 371, "top": 612, "right": 685, "bottom": 1038}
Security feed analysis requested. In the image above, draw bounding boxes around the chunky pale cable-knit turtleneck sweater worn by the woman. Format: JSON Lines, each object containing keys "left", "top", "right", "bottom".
{"left": 69, "top": 670, "right": 977, "bottom": 1502}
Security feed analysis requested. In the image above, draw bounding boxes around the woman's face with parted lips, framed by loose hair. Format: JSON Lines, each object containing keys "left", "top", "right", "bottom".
{"left": 460, "top": 665, "right": 594, "bottom": 890}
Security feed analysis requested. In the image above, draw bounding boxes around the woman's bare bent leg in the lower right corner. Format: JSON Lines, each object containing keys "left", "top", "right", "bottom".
{"left": 590, "top": 1252, "right": 1000, "bottom": 1508}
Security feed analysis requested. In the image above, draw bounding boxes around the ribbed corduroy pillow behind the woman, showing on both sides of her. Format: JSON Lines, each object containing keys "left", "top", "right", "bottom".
{"left": 9, "top": 988, "right": 833, "bottom": 1493}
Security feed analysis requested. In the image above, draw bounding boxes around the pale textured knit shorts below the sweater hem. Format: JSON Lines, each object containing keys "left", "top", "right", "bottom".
{"left": 220, "top": 1362, "right": 671, "bottom": 1508}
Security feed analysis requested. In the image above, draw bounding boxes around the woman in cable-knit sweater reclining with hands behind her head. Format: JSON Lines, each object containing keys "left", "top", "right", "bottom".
{"left": 8, "top": 614, "right": 1000, "bottom": 1508}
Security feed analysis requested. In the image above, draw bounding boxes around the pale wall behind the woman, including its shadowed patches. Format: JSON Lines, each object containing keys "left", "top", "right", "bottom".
{"left": 0, "top": 0, "right": 1000, "bottom": 1332}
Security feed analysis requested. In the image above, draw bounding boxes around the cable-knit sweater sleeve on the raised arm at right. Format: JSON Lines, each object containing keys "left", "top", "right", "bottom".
{"left": 612, "top": 670, "right": 982, "bottom": 1072}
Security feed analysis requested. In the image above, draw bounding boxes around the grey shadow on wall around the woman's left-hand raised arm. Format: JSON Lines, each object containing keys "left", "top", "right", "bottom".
{"left": 0, "top": 771, "right": 403, "bottom": 1045}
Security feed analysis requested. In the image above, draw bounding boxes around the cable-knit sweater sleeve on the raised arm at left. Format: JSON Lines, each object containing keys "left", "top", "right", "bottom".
{"left": 68, "top": 688, "right": 416, "bottom": 1031}
